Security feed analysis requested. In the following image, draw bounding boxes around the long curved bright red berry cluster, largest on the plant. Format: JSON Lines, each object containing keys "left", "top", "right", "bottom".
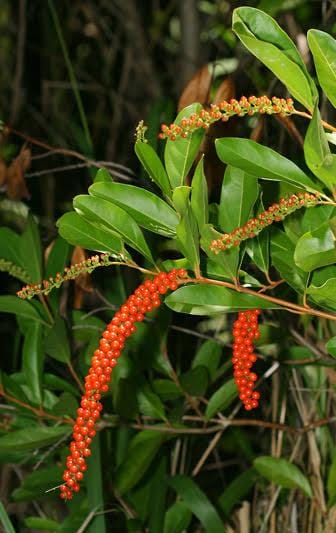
{"left": 60, "top": 269, "right": 186, "bottom": 500}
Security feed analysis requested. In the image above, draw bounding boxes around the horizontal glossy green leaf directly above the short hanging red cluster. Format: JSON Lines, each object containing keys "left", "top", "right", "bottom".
{"left": 165, "top": 285, "right": 279, "bottom": 315}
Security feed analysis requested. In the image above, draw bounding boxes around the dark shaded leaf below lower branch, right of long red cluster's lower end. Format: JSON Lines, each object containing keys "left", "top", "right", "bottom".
{"left": 115, "top": 431, "right": 166, "bottom": 494}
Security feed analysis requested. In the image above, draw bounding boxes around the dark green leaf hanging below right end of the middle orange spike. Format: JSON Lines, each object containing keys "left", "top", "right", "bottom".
{"left": 271, "top": 229, "right": 308, "bottom": 293}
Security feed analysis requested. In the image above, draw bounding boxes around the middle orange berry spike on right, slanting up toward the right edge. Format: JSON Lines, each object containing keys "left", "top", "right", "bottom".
{"left": 210, "top": 192, "right": 320, "bottom": 255}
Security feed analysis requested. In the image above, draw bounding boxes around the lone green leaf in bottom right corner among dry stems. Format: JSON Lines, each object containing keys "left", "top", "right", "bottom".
{"left": 253, "top": 455, "right": 313, "bottom": 498}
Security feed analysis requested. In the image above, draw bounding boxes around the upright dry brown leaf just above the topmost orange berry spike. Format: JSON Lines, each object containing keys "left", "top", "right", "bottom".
{"left": 177, "top": 64, "right": 212, "bottom": 111}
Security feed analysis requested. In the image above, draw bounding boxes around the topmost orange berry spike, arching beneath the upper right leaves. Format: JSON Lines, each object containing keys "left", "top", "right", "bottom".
{"left": 159, "top": 96, "right": 295, "bottom": 141}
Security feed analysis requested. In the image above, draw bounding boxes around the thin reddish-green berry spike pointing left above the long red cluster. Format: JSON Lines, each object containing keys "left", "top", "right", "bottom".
{"left": 16, "top": 254, "right": 115, "bottom": 300}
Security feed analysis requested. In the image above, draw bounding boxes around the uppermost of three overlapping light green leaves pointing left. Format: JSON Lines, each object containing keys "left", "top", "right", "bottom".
{"left": 89, "top": 183, "right": 179, "bottom": 237}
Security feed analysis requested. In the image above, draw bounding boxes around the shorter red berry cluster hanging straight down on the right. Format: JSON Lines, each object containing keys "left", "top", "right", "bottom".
{"left": 232, "top": 309, "right": 260, "bottom": 411}
